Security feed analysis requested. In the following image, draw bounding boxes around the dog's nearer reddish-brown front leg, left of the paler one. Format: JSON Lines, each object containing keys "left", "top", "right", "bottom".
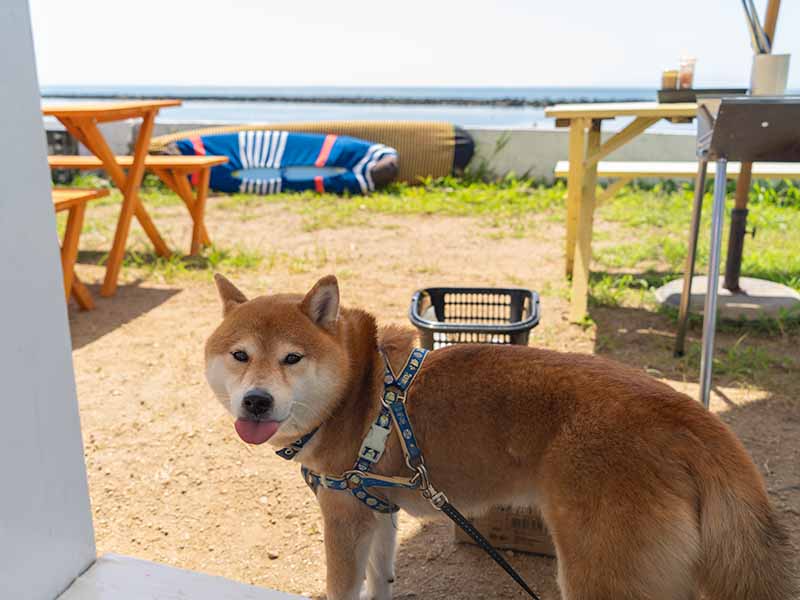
{"left": 317, "top": 489, "right": 377, "bottom": 600}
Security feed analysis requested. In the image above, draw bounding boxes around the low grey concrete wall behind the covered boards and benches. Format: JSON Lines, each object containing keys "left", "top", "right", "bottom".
{"left": 47, "top": 122, "right": 695, "bottom": 179}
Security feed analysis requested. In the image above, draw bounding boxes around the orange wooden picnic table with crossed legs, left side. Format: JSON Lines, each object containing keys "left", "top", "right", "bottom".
{"left": 42, "top": 100, "right": 181, "bottom": 296}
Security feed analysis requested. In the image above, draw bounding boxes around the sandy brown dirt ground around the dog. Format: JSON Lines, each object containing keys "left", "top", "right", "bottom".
{"left": 65, "top": 199, "right": 800, "bottom": 600}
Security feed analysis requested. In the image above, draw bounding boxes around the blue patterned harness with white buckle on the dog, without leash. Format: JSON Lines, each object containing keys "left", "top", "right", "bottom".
{"left": 276, "top": 348, "right": 428, "bottom": 513}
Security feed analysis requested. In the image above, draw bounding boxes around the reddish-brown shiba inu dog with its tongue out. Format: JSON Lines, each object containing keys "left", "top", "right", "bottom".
{"left": 205, "top": 276, "right": 798, "bottom": 600}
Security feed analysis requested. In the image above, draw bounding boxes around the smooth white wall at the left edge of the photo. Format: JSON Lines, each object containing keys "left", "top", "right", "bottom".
{"left": 0, "top": 0, "right": 95, "bottom": 600}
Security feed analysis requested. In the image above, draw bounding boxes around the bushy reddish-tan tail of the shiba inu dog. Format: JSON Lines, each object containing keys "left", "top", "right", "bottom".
{"left": 698, "top": 458, "right": 800, "bottom": 600}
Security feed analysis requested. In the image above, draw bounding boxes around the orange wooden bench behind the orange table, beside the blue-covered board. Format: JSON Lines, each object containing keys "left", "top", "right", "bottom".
{"left": 47, "top": 155, "right": 228, "bottom": 254}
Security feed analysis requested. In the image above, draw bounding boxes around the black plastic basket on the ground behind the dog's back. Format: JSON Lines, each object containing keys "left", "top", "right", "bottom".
{"left": 408, "top": 287, "right": 539, "bottom": 350}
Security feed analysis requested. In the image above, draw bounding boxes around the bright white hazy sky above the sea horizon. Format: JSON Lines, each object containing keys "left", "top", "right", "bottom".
{"left": 29, "top": 0, "right": 800, "bottom": 89}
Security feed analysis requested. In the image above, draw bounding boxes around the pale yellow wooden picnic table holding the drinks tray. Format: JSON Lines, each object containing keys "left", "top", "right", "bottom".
{"left": 545, "top": 102, "right": 697, "bottom": 322}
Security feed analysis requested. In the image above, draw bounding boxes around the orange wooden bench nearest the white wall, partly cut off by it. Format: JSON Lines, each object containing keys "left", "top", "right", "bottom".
{"left": 53, "top": 188, "right": 108, "bottom": 310}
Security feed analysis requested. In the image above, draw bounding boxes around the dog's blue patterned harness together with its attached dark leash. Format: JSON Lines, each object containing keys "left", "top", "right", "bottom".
{"left": 276, "top": 348, "right": 541, "bottom": 600}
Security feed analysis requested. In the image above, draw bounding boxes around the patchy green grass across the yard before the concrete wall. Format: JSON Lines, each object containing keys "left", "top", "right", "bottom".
{"left": 67, "top": 173, "right": 800, "bottom": 306}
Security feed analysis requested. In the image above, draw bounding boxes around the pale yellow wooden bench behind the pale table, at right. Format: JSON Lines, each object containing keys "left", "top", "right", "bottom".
{"left": 554, "top": 160, "right": 800, "bottom": 203}
